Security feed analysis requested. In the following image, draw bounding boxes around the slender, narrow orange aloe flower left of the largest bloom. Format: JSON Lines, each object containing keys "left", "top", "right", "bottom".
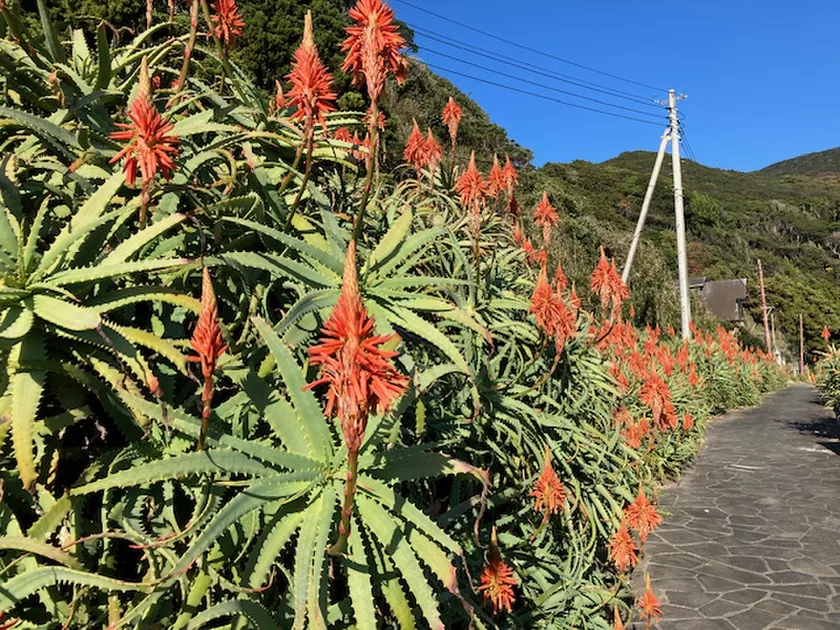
{"left": 189, "top": 267, "right": 227, "bottom": 450}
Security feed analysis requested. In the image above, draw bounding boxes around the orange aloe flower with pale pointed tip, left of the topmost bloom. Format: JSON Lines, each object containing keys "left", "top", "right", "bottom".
{"left": 286, "top": 11, "right": 336, "bottom": 131}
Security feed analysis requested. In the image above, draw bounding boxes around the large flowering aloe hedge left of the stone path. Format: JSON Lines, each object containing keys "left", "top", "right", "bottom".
{"left": 0, "top": 0, "right": 783, "bottom": 628}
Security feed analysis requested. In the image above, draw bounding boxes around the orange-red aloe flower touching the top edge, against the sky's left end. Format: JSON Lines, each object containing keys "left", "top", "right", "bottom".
{"left": 341, "top": 0, "right": 408, "bottom": 103}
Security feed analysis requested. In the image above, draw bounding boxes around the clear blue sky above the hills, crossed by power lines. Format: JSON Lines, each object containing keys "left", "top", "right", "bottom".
{"left": 391, "top": 0, "right": 840, "bottom": 171}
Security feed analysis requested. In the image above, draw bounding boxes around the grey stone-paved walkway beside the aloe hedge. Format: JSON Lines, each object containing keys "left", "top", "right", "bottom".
{"left": 634, "top": 385, "right": 840, "bottom": 630}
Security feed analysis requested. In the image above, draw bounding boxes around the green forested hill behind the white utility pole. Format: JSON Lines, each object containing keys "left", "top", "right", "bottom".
{"left": 538, "top": 151, "right": 840, "bottom": 356}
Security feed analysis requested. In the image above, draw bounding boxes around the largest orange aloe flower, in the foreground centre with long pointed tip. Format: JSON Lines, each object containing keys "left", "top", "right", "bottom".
{"left": 306, "top": 241, "right": 408, "bottom": 453}
